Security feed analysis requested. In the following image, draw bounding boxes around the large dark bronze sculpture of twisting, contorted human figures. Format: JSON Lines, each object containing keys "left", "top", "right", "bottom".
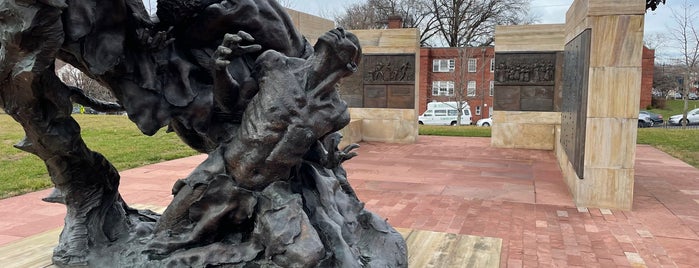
{"left": 0, "top": 0, "right": 407, "bottom": 267}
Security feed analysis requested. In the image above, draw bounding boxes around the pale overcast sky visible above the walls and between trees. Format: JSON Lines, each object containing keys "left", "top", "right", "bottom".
{"left": 287, "top": 0, "right": 688, "bottom": 60}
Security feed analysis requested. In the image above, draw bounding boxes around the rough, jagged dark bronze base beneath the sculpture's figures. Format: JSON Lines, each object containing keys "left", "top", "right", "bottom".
{"left": 46, "top": 162, "right": 407, "bottom": 267}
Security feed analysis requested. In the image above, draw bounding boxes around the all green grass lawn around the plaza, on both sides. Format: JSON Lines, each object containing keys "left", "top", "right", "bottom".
{"left": 0, "top": 113, "right": 699, "bottom": 199}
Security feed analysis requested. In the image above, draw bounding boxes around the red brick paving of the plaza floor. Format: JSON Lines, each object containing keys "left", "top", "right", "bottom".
{"left": 0, "top": 136, "right": 699, "bottom": 267}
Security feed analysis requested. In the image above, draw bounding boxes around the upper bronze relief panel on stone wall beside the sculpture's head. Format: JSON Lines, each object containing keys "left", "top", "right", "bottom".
{"left": 362, "top": 54, "right": 415, "bottom": 84}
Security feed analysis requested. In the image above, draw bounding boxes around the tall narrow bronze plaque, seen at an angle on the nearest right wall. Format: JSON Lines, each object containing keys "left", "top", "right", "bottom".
{"left": 561, "top": 29, "right": 591, "bottom": 179}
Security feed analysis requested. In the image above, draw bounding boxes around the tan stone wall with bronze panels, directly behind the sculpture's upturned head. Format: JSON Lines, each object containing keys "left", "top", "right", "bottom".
{"left": 339, "top": 28, "right": 420, "bottom": 146}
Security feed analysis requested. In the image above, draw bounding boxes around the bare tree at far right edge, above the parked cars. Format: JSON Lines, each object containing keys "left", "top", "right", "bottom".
{"left": 668, "top": 0, "right": 699, "bottom": 125}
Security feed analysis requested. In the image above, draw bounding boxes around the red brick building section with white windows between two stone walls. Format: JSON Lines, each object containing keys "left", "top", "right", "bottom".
{"left": 418, "top": 46, "right": 495, "bottom": 122}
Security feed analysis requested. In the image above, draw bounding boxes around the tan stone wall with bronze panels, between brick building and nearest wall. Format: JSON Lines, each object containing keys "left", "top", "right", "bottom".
{"left": 491, "top": 25, "right": 565, "bottom": 150}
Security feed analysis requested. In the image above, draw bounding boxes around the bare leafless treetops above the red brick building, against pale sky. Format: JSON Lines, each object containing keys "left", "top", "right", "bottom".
{"left": 335, "top": 0, "right": 533, "bottom": 47}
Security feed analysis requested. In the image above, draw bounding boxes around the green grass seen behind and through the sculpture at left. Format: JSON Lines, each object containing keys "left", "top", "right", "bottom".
{"left": 0, "top": 114, "right": 197, "bottom": 198}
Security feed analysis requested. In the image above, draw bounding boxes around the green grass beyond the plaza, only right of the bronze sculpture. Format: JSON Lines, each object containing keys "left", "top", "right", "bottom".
{"left": 419, "top": 123, "right": 699, "bottom": 168}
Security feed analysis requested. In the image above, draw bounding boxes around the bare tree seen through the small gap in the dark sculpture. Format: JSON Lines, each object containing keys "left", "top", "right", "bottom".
{"left": 57, "top": 65, "right": 116, "bottom": 102}
